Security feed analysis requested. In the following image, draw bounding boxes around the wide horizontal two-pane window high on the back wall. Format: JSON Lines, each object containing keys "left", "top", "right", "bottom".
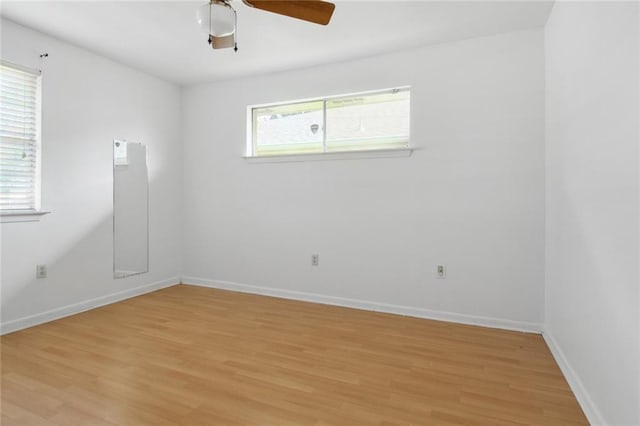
{"left": 247, "top": 87, "right": 410, "bottom": 157}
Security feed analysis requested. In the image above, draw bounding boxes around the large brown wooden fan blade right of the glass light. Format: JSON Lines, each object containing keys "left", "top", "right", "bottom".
{"left": 242, "top": 0, "right": 336, "bottom": 25}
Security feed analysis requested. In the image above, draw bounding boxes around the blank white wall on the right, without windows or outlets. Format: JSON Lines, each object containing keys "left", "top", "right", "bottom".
{"left": 545, "top": 2, "right": 640, "bottom": 425}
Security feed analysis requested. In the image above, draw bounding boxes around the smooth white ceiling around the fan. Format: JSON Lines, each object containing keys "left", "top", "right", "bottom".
{"left": 1, "top": 0, "right": 552, "bottom": 85}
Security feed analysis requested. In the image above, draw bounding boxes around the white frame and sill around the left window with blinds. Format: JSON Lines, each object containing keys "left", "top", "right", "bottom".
{"left": 0, "top": 59, "right": 49, "bottom": 223}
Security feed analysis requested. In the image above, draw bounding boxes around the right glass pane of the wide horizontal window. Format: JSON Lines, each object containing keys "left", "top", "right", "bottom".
{"left": 326, "top": 89, "right": 410, "bottom": 152}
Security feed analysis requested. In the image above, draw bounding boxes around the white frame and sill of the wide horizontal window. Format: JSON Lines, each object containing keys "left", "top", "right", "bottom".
{"left": 243, "top": 86, "right": 414, "bottom": 163}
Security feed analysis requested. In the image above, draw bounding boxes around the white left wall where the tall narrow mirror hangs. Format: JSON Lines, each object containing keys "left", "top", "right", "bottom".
{"left": 0, "top": 20, "right": 182, "bottom": 330}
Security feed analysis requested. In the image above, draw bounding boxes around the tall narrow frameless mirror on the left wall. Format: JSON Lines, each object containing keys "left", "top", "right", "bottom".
{"left": 113, "top": 140, "right": 149, "bottom": 278}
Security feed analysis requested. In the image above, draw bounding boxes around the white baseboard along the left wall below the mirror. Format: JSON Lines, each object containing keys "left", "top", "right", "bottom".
{"left": 0, "top": 277, "right": 180, "bottom": 335}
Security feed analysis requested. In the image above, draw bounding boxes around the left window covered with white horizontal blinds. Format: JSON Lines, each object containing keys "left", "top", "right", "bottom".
{"left": 0, "top": 61, "right": 40, "bottom": 213}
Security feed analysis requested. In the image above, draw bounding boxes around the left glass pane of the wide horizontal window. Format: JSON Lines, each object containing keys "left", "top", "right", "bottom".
{"left": 253, "top": 100, "right": 324, "bottom": 156}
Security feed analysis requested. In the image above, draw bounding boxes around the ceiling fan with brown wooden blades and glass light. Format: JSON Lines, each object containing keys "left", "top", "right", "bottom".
{"left": 197, "top": 0, "right": 336, "bottom": 51}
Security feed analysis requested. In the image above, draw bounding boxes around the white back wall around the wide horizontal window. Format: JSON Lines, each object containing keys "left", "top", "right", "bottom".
{"left": 183, "top": 29, "right": 544, "bottom": 329}
